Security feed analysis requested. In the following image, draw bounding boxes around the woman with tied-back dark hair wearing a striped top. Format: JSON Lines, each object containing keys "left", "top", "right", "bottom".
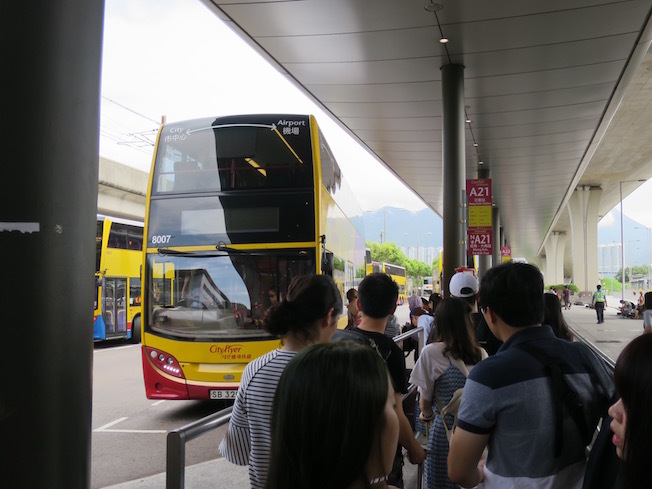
{"left": 220, "top": 275, "right": 342, "bottom": 489}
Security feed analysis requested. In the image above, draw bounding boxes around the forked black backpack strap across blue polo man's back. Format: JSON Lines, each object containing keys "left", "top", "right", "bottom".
{"left": 514, "top": 343, "right": 593, "bottom": 457}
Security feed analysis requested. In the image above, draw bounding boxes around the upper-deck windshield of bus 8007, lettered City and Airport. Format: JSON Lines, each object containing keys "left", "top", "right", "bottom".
{"left": 152, "top": 115, "right": 313, "bottom": 195}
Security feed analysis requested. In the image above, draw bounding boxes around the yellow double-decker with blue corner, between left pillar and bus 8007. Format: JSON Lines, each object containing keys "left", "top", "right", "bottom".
{"left": 93, "top": 216, "right": 143, "bottom": 343}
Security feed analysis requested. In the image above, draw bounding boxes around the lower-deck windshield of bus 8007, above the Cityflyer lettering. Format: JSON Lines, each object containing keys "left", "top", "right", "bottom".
{"left": 146, "top": 250, "right": 315, "bottom": 341}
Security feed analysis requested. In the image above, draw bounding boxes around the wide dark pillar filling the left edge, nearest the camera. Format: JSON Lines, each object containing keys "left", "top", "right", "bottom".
{"left": 0, "top": 0, "right": 104, "bottom": 489}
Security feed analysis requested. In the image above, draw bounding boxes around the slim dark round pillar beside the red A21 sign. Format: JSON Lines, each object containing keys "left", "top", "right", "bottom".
{"left": 441, "top": 65, "right": 466, "bottom": 297}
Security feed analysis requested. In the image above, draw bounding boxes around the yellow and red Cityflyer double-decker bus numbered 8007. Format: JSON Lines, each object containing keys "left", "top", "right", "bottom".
{"left": 142, "top": 115, "right": 365, "bottom": 399}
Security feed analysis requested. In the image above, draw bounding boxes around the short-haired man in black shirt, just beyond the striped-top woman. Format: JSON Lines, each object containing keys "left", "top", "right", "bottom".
{"left": 354, "top": 273, "right": 426, "bottom": 487}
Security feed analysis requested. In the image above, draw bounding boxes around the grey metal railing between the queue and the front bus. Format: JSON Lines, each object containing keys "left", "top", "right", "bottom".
{"left": 165, "top": 328, "right": 424, "bottom": 489}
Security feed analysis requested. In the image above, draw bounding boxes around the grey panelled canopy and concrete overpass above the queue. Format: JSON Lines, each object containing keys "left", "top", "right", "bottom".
{"left": 204, "top": 0, "right": 652, "bottom": 259}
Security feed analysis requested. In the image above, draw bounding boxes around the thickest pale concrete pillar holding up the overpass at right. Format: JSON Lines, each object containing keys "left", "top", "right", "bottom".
{"left": 568, "top": 185, "right": 602, "bottom": 291}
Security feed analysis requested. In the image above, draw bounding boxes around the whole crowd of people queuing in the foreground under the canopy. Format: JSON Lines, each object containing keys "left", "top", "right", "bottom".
{"left": 220, "top": 262, "right": 652, "bottom": 489}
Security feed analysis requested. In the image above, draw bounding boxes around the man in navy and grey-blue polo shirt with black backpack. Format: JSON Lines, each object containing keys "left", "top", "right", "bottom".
{"left": 448, "top": 262, "right": 613, "bottom": 489}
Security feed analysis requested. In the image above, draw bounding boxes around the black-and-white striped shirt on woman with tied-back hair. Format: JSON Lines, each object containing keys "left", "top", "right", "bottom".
{"left": 219, "top": 350, "right": 295, "bottom": 489}
